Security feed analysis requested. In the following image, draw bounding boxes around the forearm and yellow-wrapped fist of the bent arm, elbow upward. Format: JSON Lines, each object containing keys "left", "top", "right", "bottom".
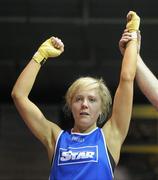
{"left": 12, "top": 37, "right": 64, "bottom": 98}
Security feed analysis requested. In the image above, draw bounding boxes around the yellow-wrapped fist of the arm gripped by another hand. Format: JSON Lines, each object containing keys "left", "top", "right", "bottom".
{"left": 126, "top": 11, "right": 140, "bottom": 32}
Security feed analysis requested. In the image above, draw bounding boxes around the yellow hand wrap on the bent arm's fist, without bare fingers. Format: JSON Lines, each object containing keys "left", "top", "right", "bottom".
{"left": 33, "top": 38, "right": 62, "bottom": 65}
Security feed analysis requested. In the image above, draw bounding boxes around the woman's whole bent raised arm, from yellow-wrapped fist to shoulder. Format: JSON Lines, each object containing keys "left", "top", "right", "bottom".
{"left": 11, "top": 37, "right": 64, "bottom": 159}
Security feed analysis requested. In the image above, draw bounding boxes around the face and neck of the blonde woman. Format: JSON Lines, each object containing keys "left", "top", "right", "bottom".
{"left": 71, "top": 89, "right": 101, "bottom": 132}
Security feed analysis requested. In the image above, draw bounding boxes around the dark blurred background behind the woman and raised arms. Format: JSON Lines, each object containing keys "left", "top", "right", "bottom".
{"left": 0, "top": 0, "right": 158, "bottom": 180}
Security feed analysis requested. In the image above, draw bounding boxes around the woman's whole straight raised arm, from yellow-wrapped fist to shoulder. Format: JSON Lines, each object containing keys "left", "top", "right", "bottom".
{"left": 103, "top": 12, "right": 140, "bottom": 163}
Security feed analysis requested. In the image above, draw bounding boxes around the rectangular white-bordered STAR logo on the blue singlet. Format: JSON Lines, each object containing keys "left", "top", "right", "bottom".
{"left": 58, "top": 146, "right": 98, "bottom": 165}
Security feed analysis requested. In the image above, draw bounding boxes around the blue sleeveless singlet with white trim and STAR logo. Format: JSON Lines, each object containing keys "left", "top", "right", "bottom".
{"left": 49, "top": 128, "right": 113, "bottom": 180}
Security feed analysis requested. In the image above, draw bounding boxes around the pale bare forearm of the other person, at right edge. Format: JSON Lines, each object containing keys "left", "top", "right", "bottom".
{"left": 136, "top": 55, "right": 158, "bottom": 109}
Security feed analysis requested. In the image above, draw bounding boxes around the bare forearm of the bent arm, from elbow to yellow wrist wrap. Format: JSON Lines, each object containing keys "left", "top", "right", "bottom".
{"left": 12, "top": 59, "right": 41, "bottom": 98}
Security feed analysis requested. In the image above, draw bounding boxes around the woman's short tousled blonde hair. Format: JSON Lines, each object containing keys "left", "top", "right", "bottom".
{"left": 65, "top": 76, "right": 112, "bottom": 126}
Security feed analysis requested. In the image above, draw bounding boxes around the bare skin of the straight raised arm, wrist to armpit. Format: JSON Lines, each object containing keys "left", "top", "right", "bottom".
{"left": 112, "top": 40, "right": 137, "bottom": 140}
